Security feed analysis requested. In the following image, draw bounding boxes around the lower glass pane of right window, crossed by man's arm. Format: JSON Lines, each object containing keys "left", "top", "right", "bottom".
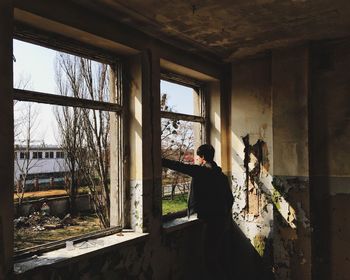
{"left": 161, "top": 118, "right": 202, "bottom": 215}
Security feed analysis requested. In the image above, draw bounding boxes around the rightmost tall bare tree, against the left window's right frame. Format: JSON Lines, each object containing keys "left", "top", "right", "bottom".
{"left": 80, "top": 59, "right": 110, "bottom": 227}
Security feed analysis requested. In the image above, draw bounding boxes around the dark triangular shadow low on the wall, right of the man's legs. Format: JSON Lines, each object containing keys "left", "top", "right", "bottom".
{"left": 225, "top": 222, "right": 275, "bottom": 280}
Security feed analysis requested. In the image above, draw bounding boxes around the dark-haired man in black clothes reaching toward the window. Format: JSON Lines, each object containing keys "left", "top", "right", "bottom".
{"left": 162, "top": 144, "right": 233, "bottom": 279}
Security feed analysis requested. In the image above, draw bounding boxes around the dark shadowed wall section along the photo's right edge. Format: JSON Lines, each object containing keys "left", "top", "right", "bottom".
{"left": 310, "top": 40, "right": 350, "bottom": 280}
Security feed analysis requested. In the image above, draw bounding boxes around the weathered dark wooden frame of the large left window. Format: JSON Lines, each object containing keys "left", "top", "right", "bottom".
{"left": 12, "top": 36, "right": 126, "bottom": 261}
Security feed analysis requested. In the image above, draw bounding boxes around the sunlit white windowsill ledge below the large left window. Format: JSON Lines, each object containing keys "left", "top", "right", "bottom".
{"left": 14, "top": 231, "right": 149, "bottom": 274}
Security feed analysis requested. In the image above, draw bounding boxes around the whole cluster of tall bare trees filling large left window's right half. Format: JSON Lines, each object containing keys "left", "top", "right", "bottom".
{"left": 56, "top": 54, "right": 110, "bottom": 227}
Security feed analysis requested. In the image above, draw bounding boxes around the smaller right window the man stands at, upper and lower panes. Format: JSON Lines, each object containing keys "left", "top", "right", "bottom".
{"left": 161, "top": 75, "right": 206, "bottom": 219}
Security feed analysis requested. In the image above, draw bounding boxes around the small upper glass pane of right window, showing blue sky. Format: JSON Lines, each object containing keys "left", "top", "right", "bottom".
{"left": 160, "top": 81, "right": 201, "bottom": 116}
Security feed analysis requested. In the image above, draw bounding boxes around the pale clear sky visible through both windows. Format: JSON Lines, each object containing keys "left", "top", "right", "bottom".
{"left": 13, "top": 40, "right": 193, "bottom": 145}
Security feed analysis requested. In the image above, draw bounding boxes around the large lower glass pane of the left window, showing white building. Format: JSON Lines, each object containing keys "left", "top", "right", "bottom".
{"left": 14, "top": 102, "right": 114, "bottom": 250}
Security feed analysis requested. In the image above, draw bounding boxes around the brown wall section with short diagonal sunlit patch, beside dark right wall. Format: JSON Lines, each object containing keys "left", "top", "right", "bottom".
{"left": 272, "top": 47, "right": 311, "bottom": 279}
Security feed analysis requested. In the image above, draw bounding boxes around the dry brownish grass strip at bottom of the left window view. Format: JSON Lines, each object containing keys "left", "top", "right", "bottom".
{"left": 14, "top": 215, "right": 101, "bottom": 250}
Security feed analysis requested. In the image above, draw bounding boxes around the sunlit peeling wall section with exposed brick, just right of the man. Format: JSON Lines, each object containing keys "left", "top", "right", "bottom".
{"left": 231, "top": 57, "right": 273, "bottom": 277}
